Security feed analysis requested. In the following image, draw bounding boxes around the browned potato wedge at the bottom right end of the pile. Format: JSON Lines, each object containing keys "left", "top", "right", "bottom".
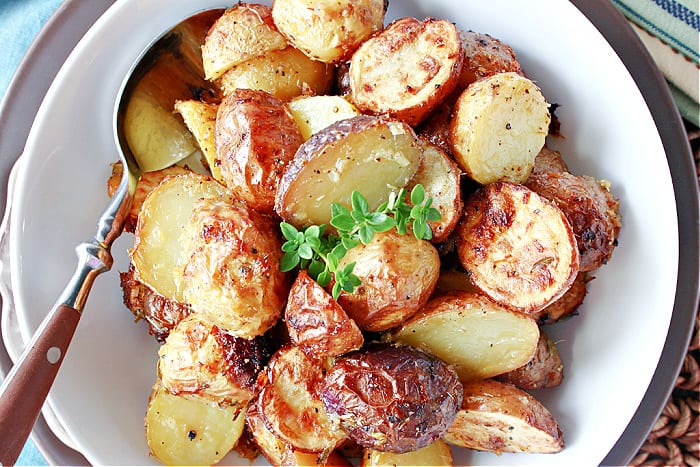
{"left": 443, "top": 380, "right": 564, "bottom": 453}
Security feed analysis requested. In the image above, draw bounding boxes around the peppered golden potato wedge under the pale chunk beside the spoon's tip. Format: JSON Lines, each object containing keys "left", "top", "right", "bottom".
{"left": 219, "top": 47, "right": 334, "bottom": 100}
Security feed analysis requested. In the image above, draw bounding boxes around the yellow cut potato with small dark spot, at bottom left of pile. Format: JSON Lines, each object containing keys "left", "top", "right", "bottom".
{"left": 145, "top": 383, "right": 245, "bottom": 465}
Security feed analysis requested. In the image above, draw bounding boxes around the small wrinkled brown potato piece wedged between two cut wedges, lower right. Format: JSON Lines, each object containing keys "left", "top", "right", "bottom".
{"left": 495, "top": 332, "right": 564, "bottom": 391}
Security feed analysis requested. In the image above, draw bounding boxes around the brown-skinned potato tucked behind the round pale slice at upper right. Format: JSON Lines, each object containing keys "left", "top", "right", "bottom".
{"left": 459, "top": 31, "right": 522, "bottom": 89}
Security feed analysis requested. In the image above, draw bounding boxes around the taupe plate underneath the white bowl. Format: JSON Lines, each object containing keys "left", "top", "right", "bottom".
{"left": 0, "top": 0, "right": 700, "bottom": 465}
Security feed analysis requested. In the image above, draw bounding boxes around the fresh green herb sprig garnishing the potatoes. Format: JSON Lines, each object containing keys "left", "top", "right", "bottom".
{"left": 280, "top": 184, "right": 441, "bottom": 299}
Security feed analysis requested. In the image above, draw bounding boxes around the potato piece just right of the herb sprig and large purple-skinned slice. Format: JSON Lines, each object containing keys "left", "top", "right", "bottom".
{"left": 406, "top": 140, "right": 463, "bottom": 243}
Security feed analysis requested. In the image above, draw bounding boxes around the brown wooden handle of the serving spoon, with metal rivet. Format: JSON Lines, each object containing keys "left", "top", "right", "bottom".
{"left": 0, "top": 305, "right": 80, "bottom": 466}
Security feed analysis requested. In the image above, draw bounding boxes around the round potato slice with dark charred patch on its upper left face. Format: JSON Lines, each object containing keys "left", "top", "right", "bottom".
{"left": 457, "top": 182, "right": 579, "bottom": 313}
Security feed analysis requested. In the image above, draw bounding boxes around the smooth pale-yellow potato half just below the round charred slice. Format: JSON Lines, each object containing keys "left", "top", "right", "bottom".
{"left": 391, "top": 292, "right": 540, "bottom": 381}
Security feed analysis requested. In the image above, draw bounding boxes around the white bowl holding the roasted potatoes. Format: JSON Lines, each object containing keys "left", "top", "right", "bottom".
{"left": 10, "top": 0, "right": 678, "bottom": 465}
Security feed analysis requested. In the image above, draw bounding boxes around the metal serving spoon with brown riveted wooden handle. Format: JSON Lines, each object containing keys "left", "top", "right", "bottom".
{"left": 0, "top": 9, "right": 223, "bottom": 466}
